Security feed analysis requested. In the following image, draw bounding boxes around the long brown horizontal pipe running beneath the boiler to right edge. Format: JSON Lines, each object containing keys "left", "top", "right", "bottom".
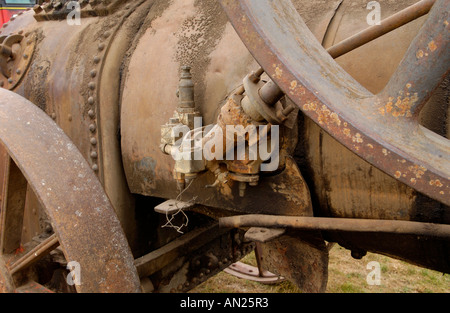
{"left": 219, "top": 214, "right": 450, "bottom": 238}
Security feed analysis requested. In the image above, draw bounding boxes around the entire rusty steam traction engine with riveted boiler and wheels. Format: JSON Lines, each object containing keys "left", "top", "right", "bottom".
{"left": 0, "top": 0, "right": 450, "bottom": 292}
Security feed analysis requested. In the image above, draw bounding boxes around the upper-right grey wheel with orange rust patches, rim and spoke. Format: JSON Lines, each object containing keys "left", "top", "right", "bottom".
{"left": 220, "top": 0, "right": 450, "bottom": 205}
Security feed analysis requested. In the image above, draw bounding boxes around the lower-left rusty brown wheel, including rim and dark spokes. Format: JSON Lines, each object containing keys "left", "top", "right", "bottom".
{"left": 0, "top": 90, "right": 140, "bottom": 292}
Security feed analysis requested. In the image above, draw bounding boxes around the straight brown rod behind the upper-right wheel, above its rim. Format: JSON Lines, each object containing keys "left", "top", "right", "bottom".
{"left": 327, "top": 0, "right": 436, "bottom": 59}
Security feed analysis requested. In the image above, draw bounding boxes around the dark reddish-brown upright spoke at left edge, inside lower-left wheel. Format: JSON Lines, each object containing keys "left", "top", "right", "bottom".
{"left": 0, "top": 145, "right": 27, "bottom": 254}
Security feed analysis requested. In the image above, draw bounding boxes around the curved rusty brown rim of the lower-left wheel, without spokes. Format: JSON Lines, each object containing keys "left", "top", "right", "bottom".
{"left": 0, "top": 90, "right": 139, "bottom": 292}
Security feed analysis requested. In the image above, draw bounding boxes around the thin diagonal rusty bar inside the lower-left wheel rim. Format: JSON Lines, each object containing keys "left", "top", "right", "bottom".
{"left": 9, "top": 234, "right": 59, "bottom": 275}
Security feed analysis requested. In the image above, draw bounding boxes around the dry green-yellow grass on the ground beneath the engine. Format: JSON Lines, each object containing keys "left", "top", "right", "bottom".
{"left": 192, "top": 245, "right": 450, "bottom": 293}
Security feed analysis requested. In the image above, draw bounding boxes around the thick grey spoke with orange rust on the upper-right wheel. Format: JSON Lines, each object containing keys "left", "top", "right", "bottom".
{"left": 380, "top": 0, "right": 450, "bottom": 118}
